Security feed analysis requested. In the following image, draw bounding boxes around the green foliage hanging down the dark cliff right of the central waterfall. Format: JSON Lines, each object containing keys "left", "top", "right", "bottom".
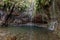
{"left": 36, "top": 0, "right": 53, "bottom": 20}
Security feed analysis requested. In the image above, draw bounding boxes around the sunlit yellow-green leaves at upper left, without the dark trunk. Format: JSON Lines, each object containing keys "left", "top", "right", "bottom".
{"left": 0, "top": 0, "right": 28, "bottom": 12}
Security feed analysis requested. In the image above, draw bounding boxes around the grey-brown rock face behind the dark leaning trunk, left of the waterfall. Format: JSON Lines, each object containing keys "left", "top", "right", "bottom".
{"left": 0, "top": 10, "right": 30, "bottom": 25}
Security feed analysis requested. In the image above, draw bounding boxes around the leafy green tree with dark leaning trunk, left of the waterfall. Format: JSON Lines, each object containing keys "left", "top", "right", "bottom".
{"left": 0, "top": 0, "right": 28, "bottom": 26}
